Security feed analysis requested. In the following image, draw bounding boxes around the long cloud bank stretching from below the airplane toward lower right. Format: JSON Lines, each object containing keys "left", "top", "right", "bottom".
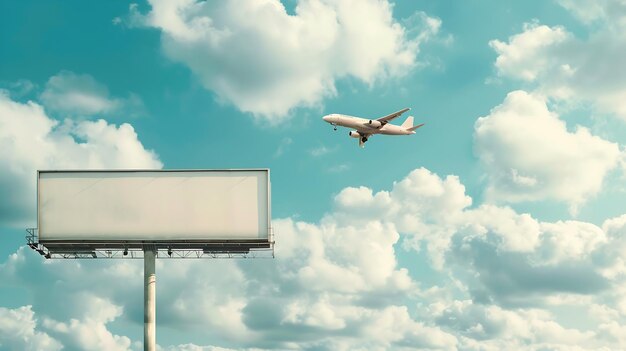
{"left": 332, "top": 168, "right": 621, "bottom": 307}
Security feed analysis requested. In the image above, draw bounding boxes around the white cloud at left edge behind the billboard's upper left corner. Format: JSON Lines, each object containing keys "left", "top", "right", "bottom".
{"left": 0, "top": 92, "right": 162, "bottom": 227}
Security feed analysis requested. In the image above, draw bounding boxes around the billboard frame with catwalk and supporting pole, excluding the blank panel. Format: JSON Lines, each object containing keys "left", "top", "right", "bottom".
{"left": 26, "top": 168, "right": 274, "bottom": 351}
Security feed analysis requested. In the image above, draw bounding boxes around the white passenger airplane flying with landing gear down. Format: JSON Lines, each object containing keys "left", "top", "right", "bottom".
{"left": 322, "top": 108, "right": 424, "bottom": 147}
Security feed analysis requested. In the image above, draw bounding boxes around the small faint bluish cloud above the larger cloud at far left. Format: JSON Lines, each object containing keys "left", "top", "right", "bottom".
{"left": 40, "top": 71, "right": 143, "bottom": 116}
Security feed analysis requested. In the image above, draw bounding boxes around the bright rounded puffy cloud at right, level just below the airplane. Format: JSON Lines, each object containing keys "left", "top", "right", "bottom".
{"left": 474, "top": 91, "right": 623, "bottom": 213}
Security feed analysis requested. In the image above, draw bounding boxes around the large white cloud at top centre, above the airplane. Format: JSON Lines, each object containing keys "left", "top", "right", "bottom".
{"left": 131, "top": 0, "right": 441, "bottom": 123}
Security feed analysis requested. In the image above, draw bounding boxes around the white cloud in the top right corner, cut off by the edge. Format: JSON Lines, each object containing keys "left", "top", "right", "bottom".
{"left": 490, "top": 10, "right": 626, "bottom": 120}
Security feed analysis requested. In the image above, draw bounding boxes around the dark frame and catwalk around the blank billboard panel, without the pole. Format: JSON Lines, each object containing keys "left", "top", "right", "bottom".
{"left": 26, "top": 168, "right": 274, "bottom": 258}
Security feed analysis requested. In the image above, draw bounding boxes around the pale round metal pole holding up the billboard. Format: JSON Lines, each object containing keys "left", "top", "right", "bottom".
{"left": 143, "top": 250, "right": 156, "bottom": 351}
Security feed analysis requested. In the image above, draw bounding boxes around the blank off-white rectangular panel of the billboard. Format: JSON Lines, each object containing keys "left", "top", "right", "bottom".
{"left": 38, "top": 169, "right": 270, "bottom": 242}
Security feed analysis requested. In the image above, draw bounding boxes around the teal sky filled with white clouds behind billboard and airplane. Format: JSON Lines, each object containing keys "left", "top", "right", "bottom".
{"left": 0, "top": 0, "right": 626, "bottom": 350}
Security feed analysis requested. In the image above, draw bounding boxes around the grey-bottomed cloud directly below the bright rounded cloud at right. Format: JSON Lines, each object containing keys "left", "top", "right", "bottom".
{"left": 446, "top": 206, "right": 611, "bottom": 308}
